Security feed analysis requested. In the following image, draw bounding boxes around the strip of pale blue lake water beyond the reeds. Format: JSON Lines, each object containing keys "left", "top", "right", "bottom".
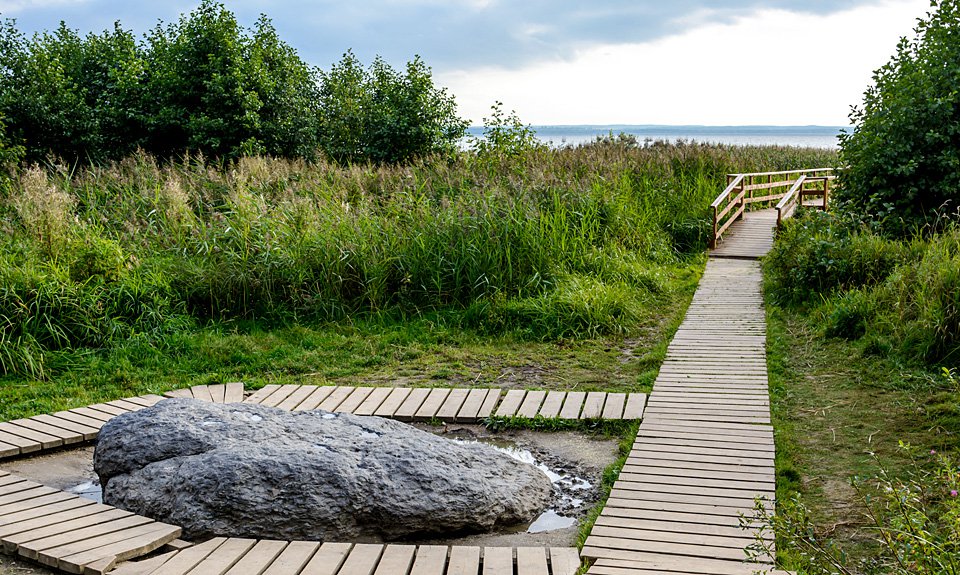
{"left": 468, "top": 125, "right": 848, "bottom": 148}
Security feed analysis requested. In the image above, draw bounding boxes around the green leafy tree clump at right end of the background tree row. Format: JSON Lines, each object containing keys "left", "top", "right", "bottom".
{"left": 320, "top": 52, "right": 467, "bottom": 163}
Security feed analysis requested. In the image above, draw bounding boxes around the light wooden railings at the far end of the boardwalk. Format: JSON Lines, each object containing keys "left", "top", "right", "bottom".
{"left": 710, "top": 168, "right": 834, "bottom": 248}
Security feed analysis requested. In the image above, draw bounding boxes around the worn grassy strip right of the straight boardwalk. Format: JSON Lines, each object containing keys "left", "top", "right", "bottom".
{"left": 767, "top": 305, "right": 960, "bottom": 568}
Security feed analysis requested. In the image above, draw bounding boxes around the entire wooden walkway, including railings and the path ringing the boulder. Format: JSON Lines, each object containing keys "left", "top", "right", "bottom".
{"left": 0, "top": 170, "right": 833, "bottom": 575}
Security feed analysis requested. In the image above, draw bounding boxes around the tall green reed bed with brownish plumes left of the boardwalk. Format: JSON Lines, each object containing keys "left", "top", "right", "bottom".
{"left": 0, "top": 140, "right": 833, "bottom": 375}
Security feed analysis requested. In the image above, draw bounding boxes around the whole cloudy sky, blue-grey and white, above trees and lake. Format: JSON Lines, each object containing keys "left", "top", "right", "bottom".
{"left": 0, "top": 0, "right": 930, "bottom": 125}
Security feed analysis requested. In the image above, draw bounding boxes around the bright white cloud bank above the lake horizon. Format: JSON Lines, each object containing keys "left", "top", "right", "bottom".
{"left": 437, "top": 0, "right": 929, "bottom": 125}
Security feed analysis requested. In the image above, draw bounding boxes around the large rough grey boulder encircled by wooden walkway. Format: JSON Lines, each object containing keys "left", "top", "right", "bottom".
{"left": 94, "top": 399, "right": 552, "bottom": 541}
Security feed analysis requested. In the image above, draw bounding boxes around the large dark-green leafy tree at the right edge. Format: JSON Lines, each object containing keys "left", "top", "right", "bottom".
{"left": 838, "top": 0, "right": 960, "bottom": 235}
